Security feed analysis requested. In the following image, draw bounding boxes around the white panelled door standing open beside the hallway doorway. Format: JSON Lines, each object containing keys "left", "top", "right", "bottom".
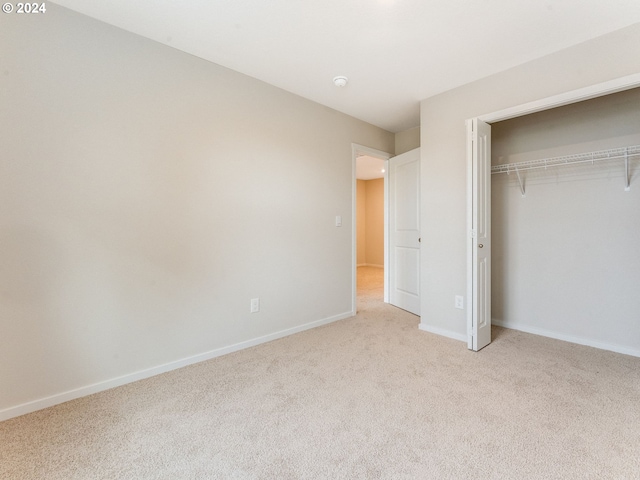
{"left": 388, "top": 148, "right": 420, "bottom": 315}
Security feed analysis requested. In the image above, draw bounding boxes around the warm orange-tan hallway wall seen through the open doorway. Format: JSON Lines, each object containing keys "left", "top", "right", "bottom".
{"left": 358, "top": 178, "right": 384, "bottom": 267}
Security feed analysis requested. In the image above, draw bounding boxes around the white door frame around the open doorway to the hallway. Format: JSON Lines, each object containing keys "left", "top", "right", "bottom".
{"left": 351, "top": 143, "right": 394, "bottom": 315}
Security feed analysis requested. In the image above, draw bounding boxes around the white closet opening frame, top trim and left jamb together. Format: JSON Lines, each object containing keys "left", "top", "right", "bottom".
{"left": 466, "top": 73, "right": 640, "bottom": 348}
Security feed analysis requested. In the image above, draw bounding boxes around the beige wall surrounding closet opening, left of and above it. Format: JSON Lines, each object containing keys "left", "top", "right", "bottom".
{"left": 420, "top": 25, "right": 640, "bottom": 348}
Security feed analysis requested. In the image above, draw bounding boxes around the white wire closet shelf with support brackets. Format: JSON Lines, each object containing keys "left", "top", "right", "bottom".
{"left": 491, "top": 145, "right": 640, "bottom": 196}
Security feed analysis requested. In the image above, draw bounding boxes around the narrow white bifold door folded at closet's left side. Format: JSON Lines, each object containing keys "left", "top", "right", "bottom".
{"left": 467, "top": 119, "right": 491, "bottom": 351}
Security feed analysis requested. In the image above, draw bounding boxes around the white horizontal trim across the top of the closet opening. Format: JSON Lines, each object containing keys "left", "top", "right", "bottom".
{"left": 478, "top": 73, "right": 640, "bottom": 123}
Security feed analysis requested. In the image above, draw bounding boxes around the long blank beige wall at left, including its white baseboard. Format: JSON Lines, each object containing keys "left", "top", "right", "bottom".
{"left": 0, "top": 4, "right": 395, "bottom": 419}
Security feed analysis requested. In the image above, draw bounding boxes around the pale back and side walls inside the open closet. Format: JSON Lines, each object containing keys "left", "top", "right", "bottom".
{"left": 492, "top": 88, "right": 640, "bottom": 356}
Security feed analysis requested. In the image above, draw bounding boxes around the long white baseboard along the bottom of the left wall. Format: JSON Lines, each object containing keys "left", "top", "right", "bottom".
{"left": 0, "top": 312, "right": 353, "bottom": 422}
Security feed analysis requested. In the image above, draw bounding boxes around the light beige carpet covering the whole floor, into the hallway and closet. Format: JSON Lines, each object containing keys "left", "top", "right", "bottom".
{"left": 0, "top": 268, "right": 640, "bottom": 480}
